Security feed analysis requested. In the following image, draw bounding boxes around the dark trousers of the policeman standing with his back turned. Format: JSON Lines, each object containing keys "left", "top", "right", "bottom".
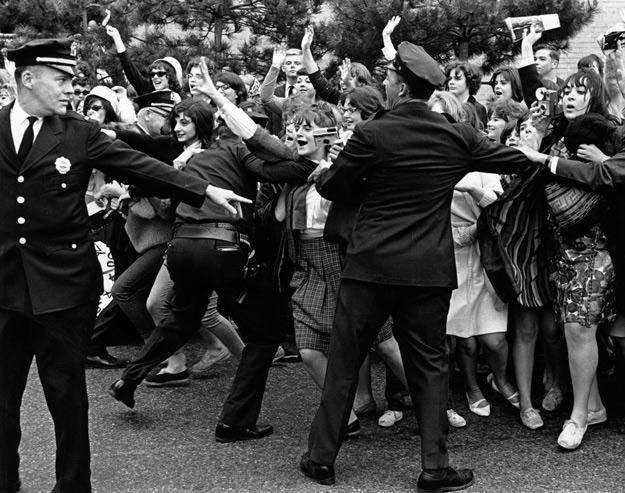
{"left": 308, "top": 279, "right": 451, "bottom": 469}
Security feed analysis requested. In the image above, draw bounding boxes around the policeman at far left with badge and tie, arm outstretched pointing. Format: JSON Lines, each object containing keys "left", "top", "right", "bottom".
{"left": 0, "top": 39, "right": 247, "bottom": 493}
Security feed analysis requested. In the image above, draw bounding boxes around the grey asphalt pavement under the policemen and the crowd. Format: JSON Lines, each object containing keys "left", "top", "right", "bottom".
{"left": 20, "top": 345, "right": 625, "bottom": 493}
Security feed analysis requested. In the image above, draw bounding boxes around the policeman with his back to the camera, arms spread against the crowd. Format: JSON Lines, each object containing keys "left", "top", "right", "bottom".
{"left": 300, "top": 42, "right": 529, "bottom": 491}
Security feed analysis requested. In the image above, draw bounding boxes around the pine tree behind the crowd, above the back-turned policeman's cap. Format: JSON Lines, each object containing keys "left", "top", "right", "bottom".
{"left": 323, "top": 0, "right": 598, "bottom": 72}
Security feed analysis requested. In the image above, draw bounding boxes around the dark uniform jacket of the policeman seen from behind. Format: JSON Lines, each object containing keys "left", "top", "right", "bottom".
{"left": 317, "top": 101, "right": 529, "bottom": 288}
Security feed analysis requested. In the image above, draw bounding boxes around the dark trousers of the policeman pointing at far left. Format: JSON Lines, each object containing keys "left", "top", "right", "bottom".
{"left": 0, "top": 300, "right": 98, "bottom": 493}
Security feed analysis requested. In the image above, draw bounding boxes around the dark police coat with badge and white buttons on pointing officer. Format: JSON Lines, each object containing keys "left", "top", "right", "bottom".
{"left": 0, "top": 107, "right": 208, "bottom": 315}
